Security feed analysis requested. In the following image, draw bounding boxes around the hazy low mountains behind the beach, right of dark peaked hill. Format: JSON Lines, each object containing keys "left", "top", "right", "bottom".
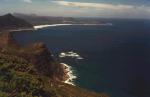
{"left": 13, "top": 13, "right": 102, "bottom": 25}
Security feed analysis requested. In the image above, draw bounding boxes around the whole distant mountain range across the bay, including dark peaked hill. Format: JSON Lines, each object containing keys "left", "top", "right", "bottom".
{"left": 0, "top": 13, "right": 105, "bottom": 31}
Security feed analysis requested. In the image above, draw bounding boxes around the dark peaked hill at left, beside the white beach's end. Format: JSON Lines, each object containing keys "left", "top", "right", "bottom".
{"left": 0, "top": 14, "right": 33, "bottom": 31}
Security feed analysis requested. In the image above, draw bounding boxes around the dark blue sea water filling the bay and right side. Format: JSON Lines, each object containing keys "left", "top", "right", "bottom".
{"left": 14, "top": 20, "right": 150, "bottom": 97}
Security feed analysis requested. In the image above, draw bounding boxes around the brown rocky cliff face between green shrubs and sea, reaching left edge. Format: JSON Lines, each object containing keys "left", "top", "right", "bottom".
{"left": 0, "top": 33, "right": 65, "bottom": 81}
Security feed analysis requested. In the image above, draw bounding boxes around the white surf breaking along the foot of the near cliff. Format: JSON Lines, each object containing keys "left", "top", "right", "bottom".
{"left": 60, "top": 63, "right": 77, "bottom": 86}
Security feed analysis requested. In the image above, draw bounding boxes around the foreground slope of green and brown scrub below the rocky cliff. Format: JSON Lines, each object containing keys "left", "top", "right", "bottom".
{"left": 0, "top": 54, "right": 107, "bottom": 97}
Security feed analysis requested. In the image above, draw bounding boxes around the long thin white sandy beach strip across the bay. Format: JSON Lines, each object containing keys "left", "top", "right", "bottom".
{"left": 34, "top": 23, "right": 113, "bottom": 30}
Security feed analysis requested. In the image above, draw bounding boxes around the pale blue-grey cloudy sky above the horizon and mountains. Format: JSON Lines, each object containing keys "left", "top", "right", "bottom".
{"left": 0, "top": 0, "right": 150, "bottom": 19}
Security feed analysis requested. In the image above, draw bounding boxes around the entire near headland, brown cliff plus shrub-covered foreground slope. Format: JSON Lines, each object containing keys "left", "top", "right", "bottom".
{"left": 0, "top": 32, "right": 108, "bottom": 97}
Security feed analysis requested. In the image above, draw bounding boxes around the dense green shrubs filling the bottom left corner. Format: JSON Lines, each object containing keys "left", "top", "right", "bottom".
{"left": 0, "top": 55, "right": 48, "bottom": 97}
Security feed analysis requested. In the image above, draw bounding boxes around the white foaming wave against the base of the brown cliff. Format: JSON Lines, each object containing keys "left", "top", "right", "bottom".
{"left": 60, "top": 63, "right": 77, "bottom": 86}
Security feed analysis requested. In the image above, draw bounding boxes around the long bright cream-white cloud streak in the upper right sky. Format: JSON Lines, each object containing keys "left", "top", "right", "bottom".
{"left": 51, "top": 1, "right": 150, "bottom": 12}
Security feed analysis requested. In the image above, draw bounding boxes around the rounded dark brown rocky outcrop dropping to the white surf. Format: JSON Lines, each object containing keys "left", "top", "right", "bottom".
{"left": 19, "top": 43, "right": 65, "bottom": 81}
